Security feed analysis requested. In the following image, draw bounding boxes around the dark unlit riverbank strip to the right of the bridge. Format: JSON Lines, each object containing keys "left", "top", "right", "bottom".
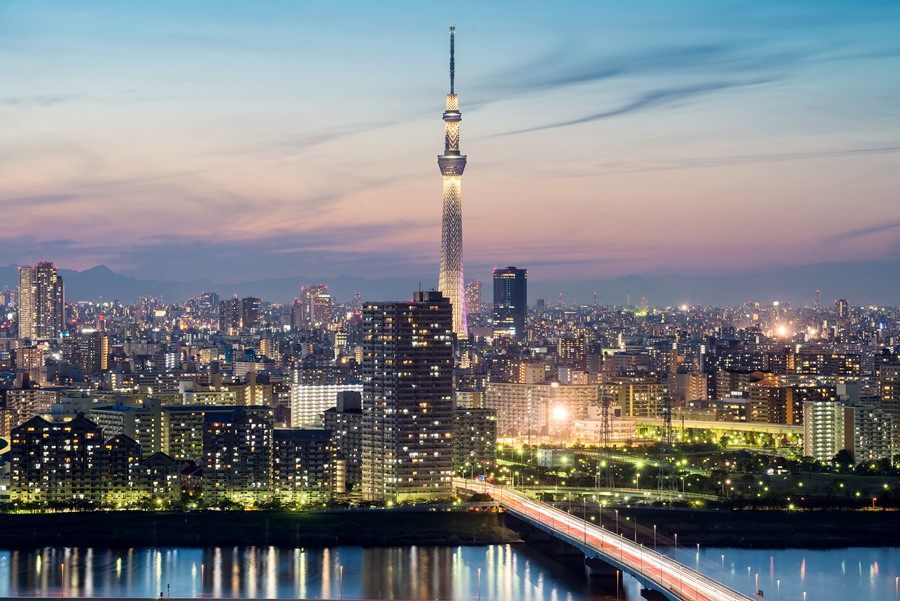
{"left": 620, "top": 507, "right": 900, "bottom": 549}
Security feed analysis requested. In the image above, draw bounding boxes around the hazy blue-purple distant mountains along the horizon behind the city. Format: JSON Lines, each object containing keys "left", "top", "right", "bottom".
{"left": 0, "top": 260, "right": 900, "bottom": 306}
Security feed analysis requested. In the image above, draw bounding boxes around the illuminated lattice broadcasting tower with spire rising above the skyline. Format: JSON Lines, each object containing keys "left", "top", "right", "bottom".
{"left": 438, "top": 27, "right": 469, "bottom": 340}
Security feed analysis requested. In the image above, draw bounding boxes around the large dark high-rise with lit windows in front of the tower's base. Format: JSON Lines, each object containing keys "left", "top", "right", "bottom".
{"left": 362, "top": 291, "right": 453, "bottom": 502}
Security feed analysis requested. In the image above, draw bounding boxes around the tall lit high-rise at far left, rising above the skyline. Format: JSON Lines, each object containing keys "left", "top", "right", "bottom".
{"left": 18, "top": 262, "right": 66, "bottom": 340}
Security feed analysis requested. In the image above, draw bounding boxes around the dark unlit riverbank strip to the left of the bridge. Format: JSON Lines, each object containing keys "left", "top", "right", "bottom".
{"left": 0, "top": 510, "right": 519, "bottom": 548}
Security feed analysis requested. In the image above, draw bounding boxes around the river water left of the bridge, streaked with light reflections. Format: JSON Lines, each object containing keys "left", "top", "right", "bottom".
{"left": 0, "top": 545, "right": 624, "bottom": 601}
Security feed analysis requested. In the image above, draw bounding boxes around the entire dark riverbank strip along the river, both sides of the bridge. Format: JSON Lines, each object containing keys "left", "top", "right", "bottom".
{"left": 0, "top": 507, "right": 900, "bottom": 549}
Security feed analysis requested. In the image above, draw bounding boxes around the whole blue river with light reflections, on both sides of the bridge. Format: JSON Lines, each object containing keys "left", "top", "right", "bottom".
{"left": 0, "top": 545, "right": 900, "bottom": 601}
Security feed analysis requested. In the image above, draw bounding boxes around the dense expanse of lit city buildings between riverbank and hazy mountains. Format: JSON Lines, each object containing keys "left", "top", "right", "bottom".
{"left": 0, "top": 263, "right": 900, "bottom": 509}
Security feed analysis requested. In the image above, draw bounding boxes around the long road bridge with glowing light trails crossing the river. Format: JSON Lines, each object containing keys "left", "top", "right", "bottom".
{"left": 453, "top": 478, "right": 751, "bottom": 601}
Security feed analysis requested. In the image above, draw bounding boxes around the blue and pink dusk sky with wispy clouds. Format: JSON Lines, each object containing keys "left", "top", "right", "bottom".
{"left": 0, "top": 0, "right": 900, "bottom": 282}
